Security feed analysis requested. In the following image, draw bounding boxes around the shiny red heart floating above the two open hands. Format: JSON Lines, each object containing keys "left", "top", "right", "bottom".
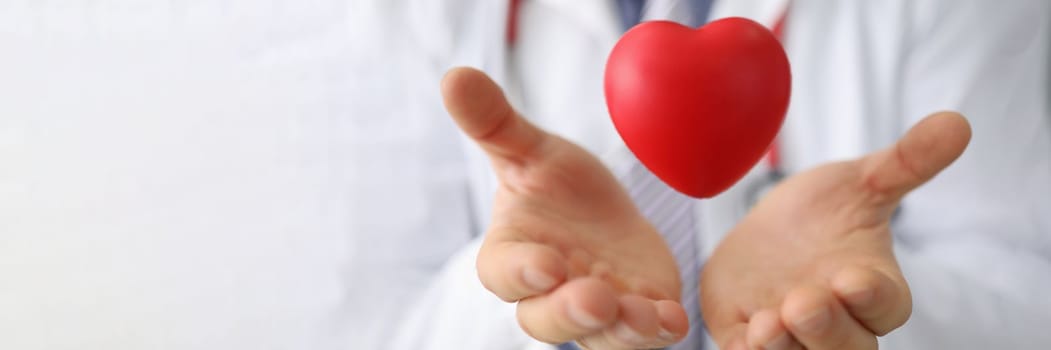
{"left": 605, "top": 18, "right": 791, "bottom": 198}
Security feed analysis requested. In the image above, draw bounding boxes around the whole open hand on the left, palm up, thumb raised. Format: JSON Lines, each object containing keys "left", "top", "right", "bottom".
{"left": 441, "top": 68, "right": 688, "bottom": 349}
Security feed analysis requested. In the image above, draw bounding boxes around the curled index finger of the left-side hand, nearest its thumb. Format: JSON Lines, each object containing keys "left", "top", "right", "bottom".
{"left": 475, "top": 239, "right": 568, "bottom": 302}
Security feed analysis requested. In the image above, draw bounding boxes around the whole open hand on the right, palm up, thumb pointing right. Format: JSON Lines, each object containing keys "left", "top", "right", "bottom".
{"left": 701, "top": 112, "right": 970, "bottom": 350}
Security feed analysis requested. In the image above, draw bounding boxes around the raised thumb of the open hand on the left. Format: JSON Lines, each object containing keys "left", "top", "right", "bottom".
{"left": 441, "top": 67, "right": 548, "bottom": 159}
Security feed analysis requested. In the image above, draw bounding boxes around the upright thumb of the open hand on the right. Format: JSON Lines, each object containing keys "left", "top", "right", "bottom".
{"left": 861, "top": 111, "right": 971, "bottom": 201}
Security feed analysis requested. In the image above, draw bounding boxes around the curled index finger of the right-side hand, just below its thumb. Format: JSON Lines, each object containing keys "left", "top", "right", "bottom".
{"left": 831, "top": 267, "right": 912, "bottom": 335}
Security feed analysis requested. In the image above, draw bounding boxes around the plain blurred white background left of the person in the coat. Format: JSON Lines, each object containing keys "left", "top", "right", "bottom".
{"left": 0, "top": 0, "right": 477, "bottom": 349}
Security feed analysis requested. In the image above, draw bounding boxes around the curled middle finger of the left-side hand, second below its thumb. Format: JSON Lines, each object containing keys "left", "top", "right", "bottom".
{"left": 517, "top": 277, "right": 620, "bottom": 344}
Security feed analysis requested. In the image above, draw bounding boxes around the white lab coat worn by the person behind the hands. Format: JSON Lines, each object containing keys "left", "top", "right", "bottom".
{"left": 397, "top": 0, "right": 1051, "bottom": 349}
